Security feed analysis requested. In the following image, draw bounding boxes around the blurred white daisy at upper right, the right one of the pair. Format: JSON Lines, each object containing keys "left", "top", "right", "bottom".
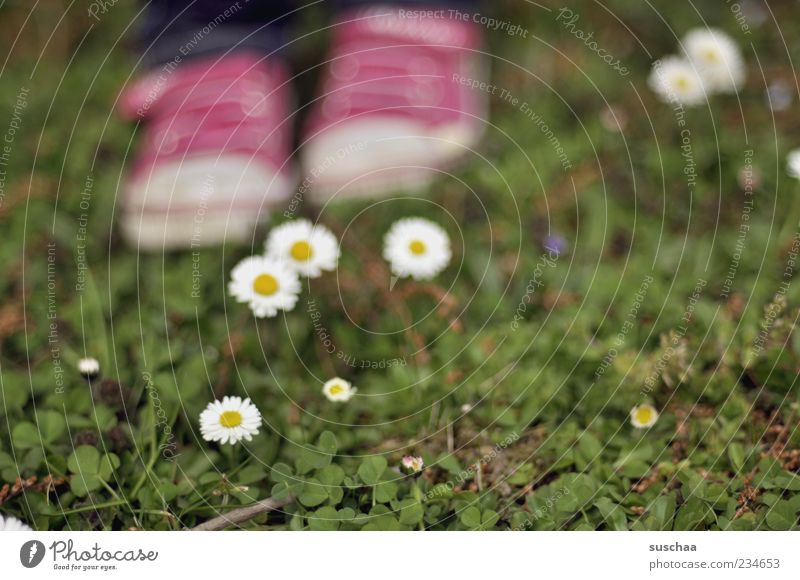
{"left": 683, "top": 28, "right": 746, "bottom": 93}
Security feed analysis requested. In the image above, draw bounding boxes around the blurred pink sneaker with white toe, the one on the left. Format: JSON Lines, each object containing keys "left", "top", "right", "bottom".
{"left": 120, "top": 53, "right": 295, "bottom": 250}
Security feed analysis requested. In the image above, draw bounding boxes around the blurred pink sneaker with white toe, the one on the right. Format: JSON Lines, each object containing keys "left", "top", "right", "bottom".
{"left": 302, "top": 6, "right": 488, "bottom": 202}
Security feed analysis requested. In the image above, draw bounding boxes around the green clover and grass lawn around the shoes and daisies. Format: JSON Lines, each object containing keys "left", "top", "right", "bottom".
{"left": 0, "top": 0, "right": 800, "bottom": 530}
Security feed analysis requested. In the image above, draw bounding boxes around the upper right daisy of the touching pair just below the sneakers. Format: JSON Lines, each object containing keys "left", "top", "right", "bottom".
{"left": 265, "top": 220, "right": 339, "bottom": 278}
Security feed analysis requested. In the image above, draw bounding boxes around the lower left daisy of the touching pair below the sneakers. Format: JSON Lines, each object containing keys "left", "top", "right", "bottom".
{"left": 228, "top": 256, "right": 300, "bottom": 318}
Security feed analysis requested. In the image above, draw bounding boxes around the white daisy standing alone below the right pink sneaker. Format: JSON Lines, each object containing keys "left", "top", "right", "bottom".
{"left": 383, "top": 218, "right": 452, "bottom": 280}
